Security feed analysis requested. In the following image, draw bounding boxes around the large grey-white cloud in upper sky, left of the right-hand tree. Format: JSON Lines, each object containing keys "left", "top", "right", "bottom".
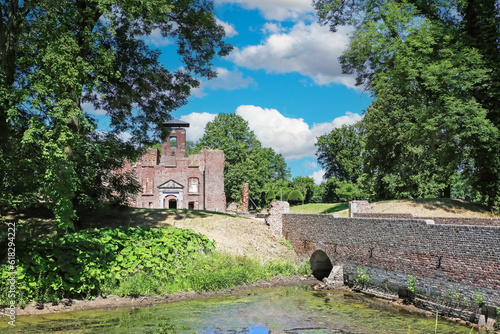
{"left": 230, "top": 22, "right": 355, "bottom": 88}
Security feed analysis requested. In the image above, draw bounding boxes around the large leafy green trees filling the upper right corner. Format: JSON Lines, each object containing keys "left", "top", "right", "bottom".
{"left": 315, "top": 0, "right": 500, "bottom": 206}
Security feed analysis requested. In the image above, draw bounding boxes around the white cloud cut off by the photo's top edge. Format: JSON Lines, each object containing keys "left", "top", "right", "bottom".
{"left": 215, "top": 0, "right": 314, "bottom": 21}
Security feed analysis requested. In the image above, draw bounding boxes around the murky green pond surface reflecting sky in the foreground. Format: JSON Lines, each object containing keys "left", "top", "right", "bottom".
{"left": 0, "top": 286, "right": 477, "bottom": 334}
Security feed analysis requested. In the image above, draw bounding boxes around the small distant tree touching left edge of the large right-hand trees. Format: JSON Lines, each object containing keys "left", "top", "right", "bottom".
{"left": 314, "top": 123, "right": 364, "bottom": 182}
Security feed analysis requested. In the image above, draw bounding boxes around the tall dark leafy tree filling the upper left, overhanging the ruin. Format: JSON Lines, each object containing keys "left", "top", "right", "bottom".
{"left": 0, "top": 0, "right": 230, "bottom": 228}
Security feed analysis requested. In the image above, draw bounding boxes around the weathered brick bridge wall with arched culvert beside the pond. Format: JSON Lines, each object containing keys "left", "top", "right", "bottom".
{"left": 283, "top": 214, "right": 500, "bottom": 307}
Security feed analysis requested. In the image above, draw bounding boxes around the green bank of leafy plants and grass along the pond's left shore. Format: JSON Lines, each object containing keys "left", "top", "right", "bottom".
{"left": 0, "top": 227, "right": 309, "bottom": 307}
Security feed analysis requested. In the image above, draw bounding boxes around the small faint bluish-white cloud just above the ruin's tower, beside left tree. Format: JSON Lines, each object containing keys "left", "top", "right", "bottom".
{"left": 192, "top": 67, "right": 255, "bottom": 97}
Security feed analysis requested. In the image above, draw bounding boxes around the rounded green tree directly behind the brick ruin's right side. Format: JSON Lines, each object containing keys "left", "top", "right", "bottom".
{"left": 195, "top": 114, "right": 290, "bottom": 205}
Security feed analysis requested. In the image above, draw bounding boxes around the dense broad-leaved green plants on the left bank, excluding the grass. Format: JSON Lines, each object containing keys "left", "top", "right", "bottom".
{"left": 1, "top": 227, "right": 214, "bottom": 303}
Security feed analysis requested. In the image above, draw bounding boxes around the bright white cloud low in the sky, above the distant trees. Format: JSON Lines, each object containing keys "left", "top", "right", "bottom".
{"left": 236, "top": 105, "right": 362, "bottom": 160}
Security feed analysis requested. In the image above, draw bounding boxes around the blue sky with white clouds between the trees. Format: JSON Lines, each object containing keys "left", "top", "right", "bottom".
{"left": 88, "top": 0, "right": 372, "bottom": 183}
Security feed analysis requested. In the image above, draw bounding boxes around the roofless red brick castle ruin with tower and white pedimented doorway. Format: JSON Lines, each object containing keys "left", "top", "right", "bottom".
{"left": 125, "top": 119, "right": 226, "bottom": 212}
